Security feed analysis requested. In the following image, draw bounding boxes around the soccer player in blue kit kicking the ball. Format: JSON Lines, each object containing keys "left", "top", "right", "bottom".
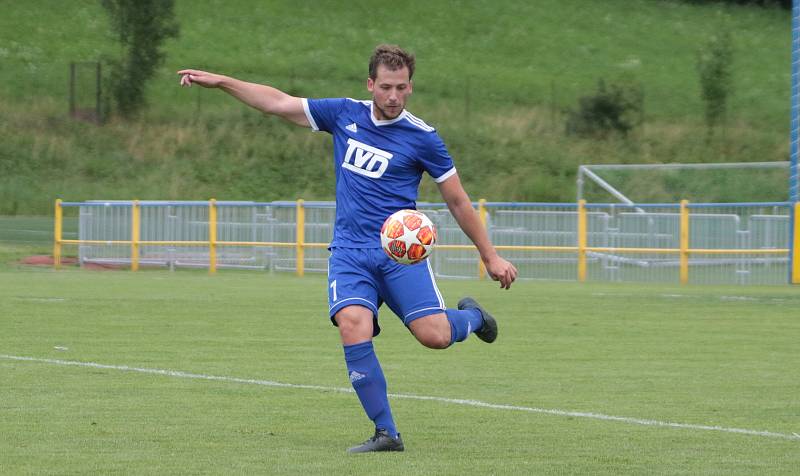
{"left": 178, "top": 45, "right": 517, "bottom": 453}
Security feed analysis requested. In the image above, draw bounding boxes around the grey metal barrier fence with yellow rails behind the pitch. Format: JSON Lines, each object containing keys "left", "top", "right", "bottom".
{"left": 54, "top": 200, "right": 800, "bottom": 284}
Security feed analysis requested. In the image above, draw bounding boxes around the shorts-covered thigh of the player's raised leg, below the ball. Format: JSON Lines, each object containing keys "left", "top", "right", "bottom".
{"left": 381, "top": 253, "right": 445, "bottom": 326}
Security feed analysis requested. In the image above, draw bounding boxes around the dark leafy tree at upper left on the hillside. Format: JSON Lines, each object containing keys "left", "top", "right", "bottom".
{"left": 100, "top": 0, "right": 179, "bottom": 117}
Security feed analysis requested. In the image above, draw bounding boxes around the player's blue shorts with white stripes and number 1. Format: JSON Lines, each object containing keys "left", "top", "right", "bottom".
{"left": 328, "top": 248, "right": 445, "bottom": 335}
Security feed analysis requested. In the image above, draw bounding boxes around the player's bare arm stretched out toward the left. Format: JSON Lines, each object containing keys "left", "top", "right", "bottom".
{"left": 178, "top": 69, "right": 311, "bottom": 127}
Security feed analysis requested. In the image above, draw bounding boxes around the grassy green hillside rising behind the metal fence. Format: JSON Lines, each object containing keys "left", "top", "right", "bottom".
{"left": 0, "top": 0, "right": 790, "bottom": 214}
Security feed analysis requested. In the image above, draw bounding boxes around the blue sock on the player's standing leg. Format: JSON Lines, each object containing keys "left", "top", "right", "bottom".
{"left": 344, "top": 341, "right": 397, "bottom": 438}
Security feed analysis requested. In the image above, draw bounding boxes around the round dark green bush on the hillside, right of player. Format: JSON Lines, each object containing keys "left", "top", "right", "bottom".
{"left": 566, "top": 80, "right": 644, "bottom": 138}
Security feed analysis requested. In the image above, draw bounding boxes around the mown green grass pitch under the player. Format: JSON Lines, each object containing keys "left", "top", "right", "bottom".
{"left": 0, "top": 266, "right": 800, "bottom": 474}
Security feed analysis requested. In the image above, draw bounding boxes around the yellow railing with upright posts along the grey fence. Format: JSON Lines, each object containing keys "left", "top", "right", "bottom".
{"left": 53, "top": 199, "right": 800, "bottom": 284}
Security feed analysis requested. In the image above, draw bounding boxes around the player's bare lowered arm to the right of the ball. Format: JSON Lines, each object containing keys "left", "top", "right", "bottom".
{"left": 439, "top": 174, "right": 517, "bottom": 289}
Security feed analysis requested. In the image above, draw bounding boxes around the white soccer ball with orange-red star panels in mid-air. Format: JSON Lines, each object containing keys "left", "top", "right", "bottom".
{"left": 381, "top": 210, "right": 436, "bottom": 264}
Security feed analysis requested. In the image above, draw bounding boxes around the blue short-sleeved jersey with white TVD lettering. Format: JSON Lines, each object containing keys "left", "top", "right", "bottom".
{"left": 303, "top": 98, "right": 456, "bottom": 248}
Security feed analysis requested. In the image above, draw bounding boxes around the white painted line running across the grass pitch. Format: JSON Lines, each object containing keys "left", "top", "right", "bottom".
{"left": 0, "top": 354, "right": 800, "bottom": 441}
